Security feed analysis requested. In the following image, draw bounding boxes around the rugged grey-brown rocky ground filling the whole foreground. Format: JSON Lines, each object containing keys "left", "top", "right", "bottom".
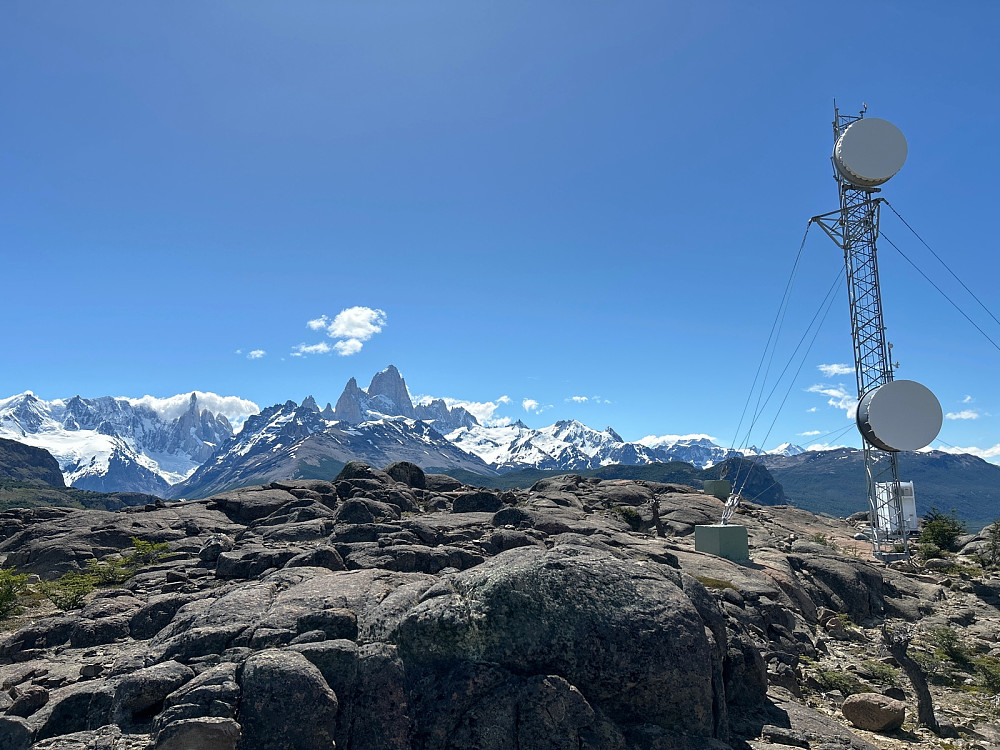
{"left": 0, "top": 463, "right": 1000, "bottom": 750}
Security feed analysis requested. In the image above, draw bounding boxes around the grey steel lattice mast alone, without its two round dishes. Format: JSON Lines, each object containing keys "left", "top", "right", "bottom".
{"left": 813, "top": 107, "right": 909, "bottom": 559}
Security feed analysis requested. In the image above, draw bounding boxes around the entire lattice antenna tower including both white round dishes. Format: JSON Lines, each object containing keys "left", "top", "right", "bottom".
{"left": 812, "top": 102, "right": 942, "bottom": 561}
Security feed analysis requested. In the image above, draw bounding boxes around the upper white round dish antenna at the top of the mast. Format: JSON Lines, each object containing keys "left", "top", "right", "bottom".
{"left": 833, "top": 117, "right": 906, "bottom": 187}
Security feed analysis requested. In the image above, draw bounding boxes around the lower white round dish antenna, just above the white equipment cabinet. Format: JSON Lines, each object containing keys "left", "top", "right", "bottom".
{"left": 857, "top": 380, "right": 943, "bottom": 452}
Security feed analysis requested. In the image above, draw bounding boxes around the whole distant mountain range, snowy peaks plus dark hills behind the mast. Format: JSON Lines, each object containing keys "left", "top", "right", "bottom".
{"left": 0, "top": 365, "right": 1000, "bottom": 523}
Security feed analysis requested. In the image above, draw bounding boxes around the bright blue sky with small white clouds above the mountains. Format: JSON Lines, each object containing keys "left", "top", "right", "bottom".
{"left": 0, "top": 0, "right": 1000, "bottom": 460}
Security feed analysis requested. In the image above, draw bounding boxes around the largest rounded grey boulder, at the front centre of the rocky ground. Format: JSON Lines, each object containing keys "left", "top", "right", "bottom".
{"left": 395, "top": 545, "right": 721, "bottom": 737}
